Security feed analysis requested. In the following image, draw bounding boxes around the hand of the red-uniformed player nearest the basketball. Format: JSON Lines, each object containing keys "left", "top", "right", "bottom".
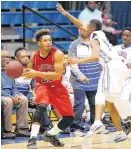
{"left": 22, "top": 68, "right": 37, "bottom": 79}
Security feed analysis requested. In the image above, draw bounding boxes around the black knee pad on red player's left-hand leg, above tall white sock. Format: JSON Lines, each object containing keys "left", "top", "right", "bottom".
{"left": 33, "top": 104, "right": 47, "bottom": 123}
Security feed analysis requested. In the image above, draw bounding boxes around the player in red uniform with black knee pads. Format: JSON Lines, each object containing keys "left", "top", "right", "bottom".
{"left": 23, "top": 29, "right": 74, "bottom": 149}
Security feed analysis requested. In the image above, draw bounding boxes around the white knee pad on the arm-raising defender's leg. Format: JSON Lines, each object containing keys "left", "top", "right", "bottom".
{"left": 95, "top": 93, "right": 108, "bottom": 106}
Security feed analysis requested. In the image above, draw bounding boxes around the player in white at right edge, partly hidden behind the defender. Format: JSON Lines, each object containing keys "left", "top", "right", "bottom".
{"left": 113, "top": 27, "right": 131, "bottom": 134}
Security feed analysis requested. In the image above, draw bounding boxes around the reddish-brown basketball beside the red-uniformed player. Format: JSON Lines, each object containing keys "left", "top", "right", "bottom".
{"left": 5, "top": 60, "right": 23, "bottom": 79}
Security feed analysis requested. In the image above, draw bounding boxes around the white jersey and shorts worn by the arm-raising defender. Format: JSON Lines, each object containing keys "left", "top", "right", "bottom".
{"left": 90, "top": 31, "right": 128, "bottom": 98}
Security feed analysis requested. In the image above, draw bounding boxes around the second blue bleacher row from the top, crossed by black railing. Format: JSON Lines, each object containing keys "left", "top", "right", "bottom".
{"left": 1, "top": 10, "right": 80, "bottom": 25}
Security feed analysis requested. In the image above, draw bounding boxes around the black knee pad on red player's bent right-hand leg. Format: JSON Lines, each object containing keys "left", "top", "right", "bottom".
{"left": 58, "top": 116, "right": 74, "bottom": 130}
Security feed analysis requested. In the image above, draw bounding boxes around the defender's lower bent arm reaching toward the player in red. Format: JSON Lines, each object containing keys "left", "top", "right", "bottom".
{"left": 67, "top": 40, "right": 100, "bottom": 64}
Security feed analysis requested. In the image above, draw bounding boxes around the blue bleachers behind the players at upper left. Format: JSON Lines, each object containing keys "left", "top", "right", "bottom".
{"left": 1, "top": 1, "right": 80, "bottom": 53}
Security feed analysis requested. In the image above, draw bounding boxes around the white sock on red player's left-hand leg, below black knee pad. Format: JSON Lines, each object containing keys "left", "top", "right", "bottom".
{"left": 30, "top": 124, "right": 40, "bottom": 138}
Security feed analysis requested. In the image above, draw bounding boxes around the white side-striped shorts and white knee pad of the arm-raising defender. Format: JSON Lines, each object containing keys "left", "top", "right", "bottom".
{"left": 96, "top": 59, "right": 128, "bottom": 105}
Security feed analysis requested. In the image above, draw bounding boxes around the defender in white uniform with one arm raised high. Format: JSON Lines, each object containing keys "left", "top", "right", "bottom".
{"left": 57, "top": 4, "right": 127, "bottom": 142}
